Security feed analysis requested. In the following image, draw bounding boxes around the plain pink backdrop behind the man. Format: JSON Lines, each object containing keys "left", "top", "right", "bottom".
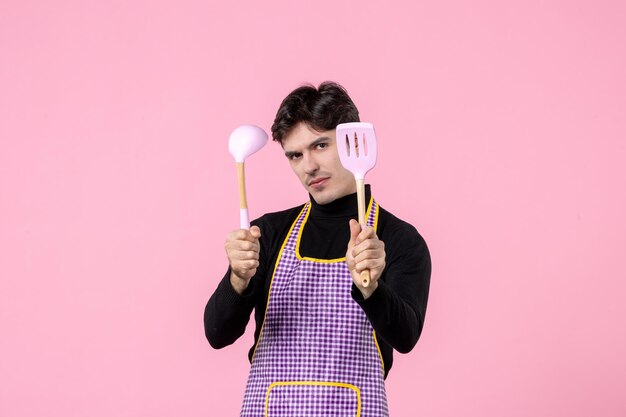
{"left": 0, "top": 0, "right": 626, "bottom": 417}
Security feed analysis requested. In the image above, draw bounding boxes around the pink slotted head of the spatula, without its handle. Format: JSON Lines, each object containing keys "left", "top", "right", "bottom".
{"left": 336, "top": 122, "right": 376, "bottom": 180}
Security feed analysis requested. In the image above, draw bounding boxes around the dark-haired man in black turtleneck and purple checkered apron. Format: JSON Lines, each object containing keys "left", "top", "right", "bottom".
{"left": 204, "top": 82, "right": 431, "bottom": 417}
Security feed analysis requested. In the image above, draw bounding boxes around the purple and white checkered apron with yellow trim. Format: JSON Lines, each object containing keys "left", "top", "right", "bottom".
{"left": 241, "top": 200, "right": 388, "bottom": 417}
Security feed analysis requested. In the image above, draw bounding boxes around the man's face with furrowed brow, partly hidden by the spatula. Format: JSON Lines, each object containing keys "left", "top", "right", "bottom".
{"left": 282, "top": 123, "right": 356, "bottom": 204}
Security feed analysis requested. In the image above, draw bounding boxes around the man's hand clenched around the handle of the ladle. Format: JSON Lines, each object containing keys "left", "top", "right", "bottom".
{"left": 224, "top": 226, "right": 261, "bottom": 295}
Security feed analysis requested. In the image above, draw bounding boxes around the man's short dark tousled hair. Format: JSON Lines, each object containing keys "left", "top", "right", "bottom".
{"left": 272, "top": 81, "right": 360, "bottom": 143}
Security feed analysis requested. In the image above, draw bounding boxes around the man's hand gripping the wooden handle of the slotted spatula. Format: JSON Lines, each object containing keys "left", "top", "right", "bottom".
{"left": 346, "top": 220, "right": 385, "bottom": 299}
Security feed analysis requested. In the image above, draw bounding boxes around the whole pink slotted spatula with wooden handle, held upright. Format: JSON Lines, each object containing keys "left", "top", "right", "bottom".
{"left": 336, "top": 122, "right": 376, "bottom": 287}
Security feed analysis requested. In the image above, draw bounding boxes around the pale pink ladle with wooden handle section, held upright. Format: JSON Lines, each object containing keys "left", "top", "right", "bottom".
{"left": 228, "top": 125, "right": 267, "bottom": 229}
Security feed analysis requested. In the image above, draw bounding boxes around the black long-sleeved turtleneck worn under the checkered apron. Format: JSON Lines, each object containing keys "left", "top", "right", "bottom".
{"left": 204, "top": 186, "right": 431, "bottom": 377}
